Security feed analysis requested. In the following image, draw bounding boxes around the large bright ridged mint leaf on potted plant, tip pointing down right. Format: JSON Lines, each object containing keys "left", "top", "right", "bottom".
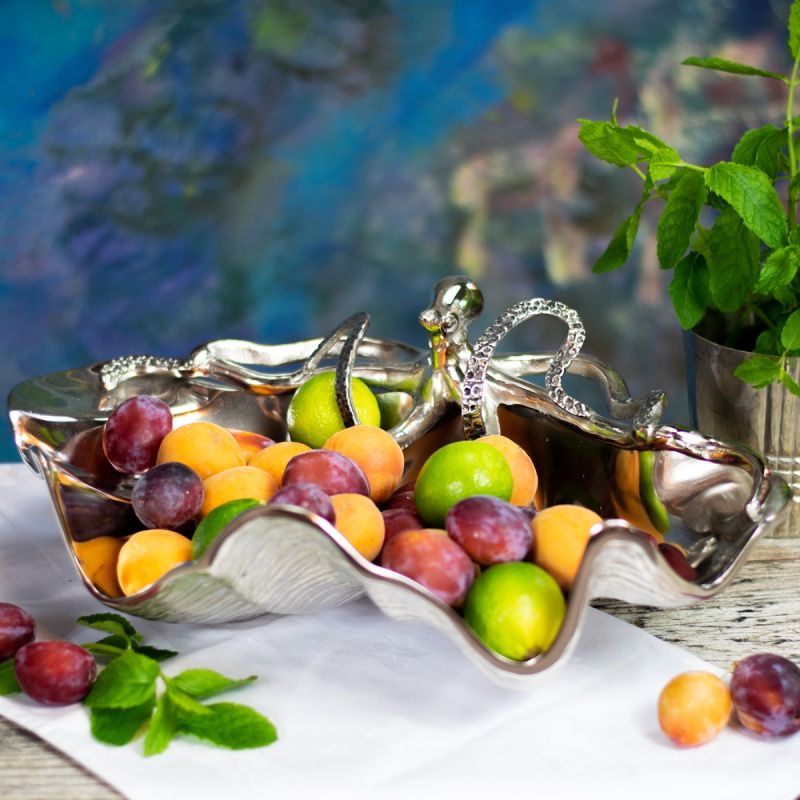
{"left": 705, "top": 161, "right": 787, "bottom": 249}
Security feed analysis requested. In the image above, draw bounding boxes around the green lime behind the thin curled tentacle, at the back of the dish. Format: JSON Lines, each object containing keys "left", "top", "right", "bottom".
{"left": 286, "top": 370, "right": 381, "bottom": 448}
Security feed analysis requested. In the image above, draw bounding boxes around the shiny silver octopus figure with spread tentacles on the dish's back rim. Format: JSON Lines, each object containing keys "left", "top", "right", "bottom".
{"left": 100, "top": 276, "right": 665, "bottom": 448}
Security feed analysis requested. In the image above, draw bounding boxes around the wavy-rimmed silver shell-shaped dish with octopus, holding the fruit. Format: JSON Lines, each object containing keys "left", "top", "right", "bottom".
{"left": 9, "top": 276, "right": 790, "bottom": 687}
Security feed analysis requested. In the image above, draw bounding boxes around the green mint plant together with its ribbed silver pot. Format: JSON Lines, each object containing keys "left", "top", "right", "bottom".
{"left": 579, "top": 0, "right": 800, "bottom": 535}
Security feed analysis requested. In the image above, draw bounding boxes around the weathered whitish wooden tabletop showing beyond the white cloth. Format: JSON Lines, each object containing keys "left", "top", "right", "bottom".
{"left": 0, "top": 539, "right": 800, "bottom": 800}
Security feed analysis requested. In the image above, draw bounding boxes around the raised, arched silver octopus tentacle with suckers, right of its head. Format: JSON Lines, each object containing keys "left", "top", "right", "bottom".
{"left": 461, "top": 297, "right": 592, "bottom": 439}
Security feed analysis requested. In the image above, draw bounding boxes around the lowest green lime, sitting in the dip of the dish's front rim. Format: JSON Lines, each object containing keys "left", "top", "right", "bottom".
{"left": 464, "top": 561, "right": 566, "bottom": 661}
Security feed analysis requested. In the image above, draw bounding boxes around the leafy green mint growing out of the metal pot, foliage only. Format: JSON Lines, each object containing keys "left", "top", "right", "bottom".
{"left": 578, "top": 0, "right": 800, "bottom": 394}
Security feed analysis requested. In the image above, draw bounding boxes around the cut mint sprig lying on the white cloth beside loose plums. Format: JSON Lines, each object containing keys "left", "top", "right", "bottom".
{"left": 79, "top": 614, "right": 277, "bottom": 756}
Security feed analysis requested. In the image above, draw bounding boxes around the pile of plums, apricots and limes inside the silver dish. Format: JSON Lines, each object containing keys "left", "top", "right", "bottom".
{"left": 74, "top": 372, "right": 691, "bottom": 660}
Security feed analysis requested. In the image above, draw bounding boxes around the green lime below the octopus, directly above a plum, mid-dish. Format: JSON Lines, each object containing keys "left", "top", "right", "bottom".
{"left": 414, "top": 442, "right": 514, "bottom": 528}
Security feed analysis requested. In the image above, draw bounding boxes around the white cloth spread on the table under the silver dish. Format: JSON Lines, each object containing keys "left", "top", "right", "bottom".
{"left": 0, "top": 465, "right": 800, "bottom": 800}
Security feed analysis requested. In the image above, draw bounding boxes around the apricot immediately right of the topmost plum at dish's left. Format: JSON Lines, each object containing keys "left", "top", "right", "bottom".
{"left": 156, "top": 422, "right": 244, "bottom": 480}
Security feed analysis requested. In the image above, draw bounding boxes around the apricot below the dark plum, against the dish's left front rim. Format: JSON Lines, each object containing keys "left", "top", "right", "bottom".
{"left": 117, "top": 528, "right": 192, "bottom": 596}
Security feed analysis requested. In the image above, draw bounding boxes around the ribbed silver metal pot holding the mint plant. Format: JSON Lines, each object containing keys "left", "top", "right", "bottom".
{"left": 684, "top": 331, "right": 800, "bottom": 537}
